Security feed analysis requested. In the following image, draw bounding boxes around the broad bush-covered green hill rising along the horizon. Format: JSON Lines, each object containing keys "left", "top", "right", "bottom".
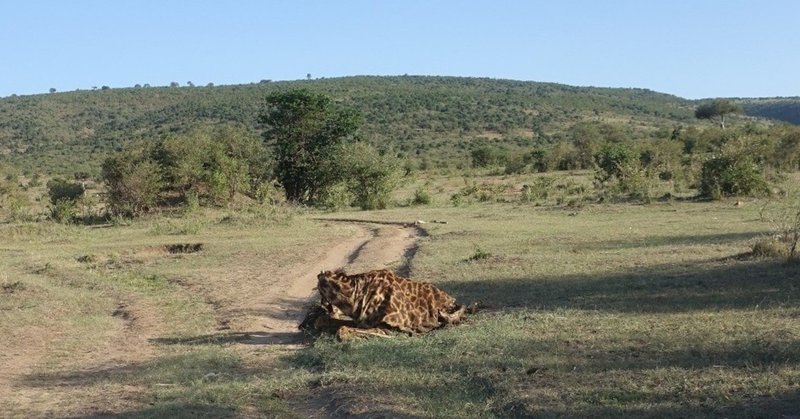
{"left": 0, "top": 76, "right": 771, "bottom": 174}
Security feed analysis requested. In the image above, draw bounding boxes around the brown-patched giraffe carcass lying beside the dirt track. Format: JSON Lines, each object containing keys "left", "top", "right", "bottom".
{"left": 300, "top": 269, "right": 474, "bottom": 340}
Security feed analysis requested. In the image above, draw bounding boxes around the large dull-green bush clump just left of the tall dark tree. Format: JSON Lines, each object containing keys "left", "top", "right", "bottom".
{"left": 102, "top": 126, "right": 271, "bottom": 216}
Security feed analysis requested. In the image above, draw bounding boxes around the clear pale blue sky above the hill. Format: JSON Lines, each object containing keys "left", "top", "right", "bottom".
{"left": 0, "top": 0, "right": 800, "bottom": 99}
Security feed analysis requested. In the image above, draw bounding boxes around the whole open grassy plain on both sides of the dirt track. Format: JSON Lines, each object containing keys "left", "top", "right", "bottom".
{"left": 0, "top": 174, "right": 800, "bottom": 417}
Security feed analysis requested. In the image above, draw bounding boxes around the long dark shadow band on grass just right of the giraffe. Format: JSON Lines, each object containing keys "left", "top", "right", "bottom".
{"left": 444, "top": 260, "right": 800, "bottom": 313}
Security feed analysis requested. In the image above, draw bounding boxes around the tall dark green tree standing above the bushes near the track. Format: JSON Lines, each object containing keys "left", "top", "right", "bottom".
{"left": 259, "top": 89, "right": 361, "bottom": 203}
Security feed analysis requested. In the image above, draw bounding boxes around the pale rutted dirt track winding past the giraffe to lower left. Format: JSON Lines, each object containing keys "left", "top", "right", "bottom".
{"left": 0, "top": 220, "right": 424, "bottom": 417}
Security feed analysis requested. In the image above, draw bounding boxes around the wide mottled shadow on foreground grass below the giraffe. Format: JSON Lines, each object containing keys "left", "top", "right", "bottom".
{"left": 290, "top": 328, "right": 800, "bottom": 418}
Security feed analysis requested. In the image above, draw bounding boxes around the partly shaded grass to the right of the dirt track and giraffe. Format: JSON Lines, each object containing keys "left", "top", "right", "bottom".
{"left": 295, "top": 202, "right": 800, "bottom": 417}
